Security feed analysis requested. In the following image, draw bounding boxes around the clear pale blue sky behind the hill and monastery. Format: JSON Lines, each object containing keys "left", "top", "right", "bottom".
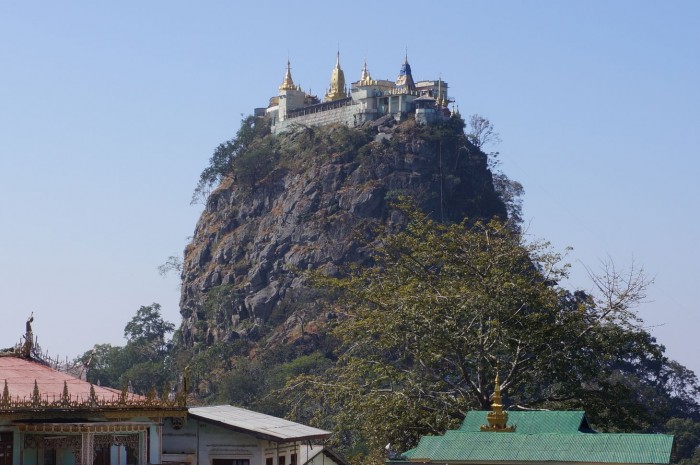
{"left": 0, "top": 0, "right": 700, "bottom": 372}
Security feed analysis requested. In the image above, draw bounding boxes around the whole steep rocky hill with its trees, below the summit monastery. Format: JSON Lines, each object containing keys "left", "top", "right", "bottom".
{"left": 79, "top": 113, "right": 700, "bottom": 463}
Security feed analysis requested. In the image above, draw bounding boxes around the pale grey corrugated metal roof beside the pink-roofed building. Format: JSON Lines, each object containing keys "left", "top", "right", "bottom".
{"left": 189, "top": 405, "right": 331, "bottom": 442}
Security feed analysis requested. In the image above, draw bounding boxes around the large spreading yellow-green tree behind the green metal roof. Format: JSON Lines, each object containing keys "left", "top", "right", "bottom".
{"left": 283, "top": 206, "right": 697, "bottom": 460}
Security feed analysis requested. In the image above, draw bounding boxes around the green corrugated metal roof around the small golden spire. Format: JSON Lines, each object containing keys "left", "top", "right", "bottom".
{"left": 404, "top": 411, "right": 673, "bottom": 464}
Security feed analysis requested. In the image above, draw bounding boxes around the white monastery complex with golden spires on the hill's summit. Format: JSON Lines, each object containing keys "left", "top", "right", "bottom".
{"left": 255, "top": 53, "right": 459, "bottom": 133}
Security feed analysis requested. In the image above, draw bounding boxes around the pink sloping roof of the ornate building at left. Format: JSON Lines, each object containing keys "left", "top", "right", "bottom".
{"left": 0, "top": 357, "right": 132, "bottom": 401}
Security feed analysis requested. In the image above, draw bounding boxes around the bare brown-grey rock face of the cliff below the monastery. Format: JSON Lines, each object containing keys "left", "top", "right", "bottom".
{"left": 180, "top": 121, "right": 506, "bottom": 346}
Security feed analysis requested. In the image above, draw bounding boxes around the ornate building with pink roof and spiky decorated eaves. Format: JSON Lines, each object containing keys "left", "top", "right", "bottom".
{"left": 0, "top": 319, "right": 187, "bottom": 465}
